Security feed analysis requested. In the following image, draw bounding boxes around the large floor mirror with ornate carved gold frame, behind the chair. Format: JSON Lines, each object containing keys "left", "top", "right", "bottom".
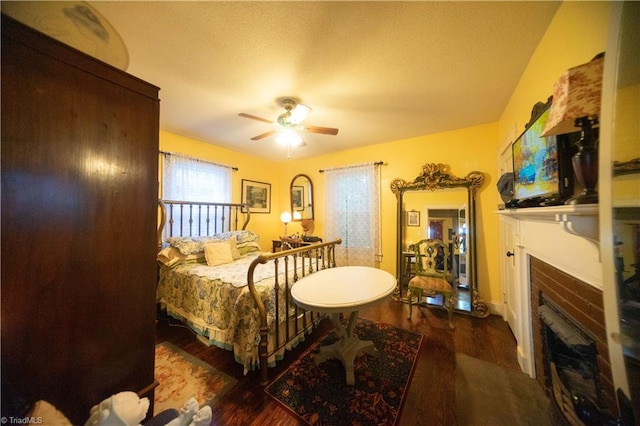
{"left": 391, "top": 163, "right": 490, "bottom": 318}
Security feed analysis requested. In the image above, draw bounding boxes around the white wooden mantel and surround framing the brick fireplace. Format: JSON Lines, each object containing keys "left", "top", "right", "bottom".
{"left": 498, "top": 204, "right": 603, "bottom": 378}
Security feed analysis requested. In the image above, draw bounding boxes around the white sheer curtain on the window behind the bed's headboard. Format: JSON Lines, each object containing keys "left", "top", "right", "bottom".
{"left": 161, "top": 153, "right": 232, "bottom": 237}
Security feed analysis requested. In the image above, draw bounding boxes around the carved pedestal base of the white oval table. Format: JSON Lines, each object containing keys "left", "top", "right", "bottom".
{"left": 314, "top": 311, "right": 380, "bottom": 386}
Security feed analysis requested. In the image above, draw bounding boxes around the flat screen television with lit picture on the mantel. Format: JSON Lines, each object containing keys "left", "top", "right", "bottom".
{"left": 511, "top": 102, "right": 575, "bottom": 207}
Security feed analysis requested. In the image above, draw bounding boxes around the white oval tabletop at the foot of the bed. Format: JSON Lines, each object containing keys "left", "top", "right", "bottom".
{"left": 291, "top": 266, "right": 396, "bottom": 313}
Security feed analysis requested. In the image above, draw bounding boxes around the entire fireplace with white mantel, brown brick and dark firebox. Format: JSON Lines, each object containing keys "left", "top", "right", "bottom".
{"left": 498, "top": 204, "right": 628, "bottom": 425}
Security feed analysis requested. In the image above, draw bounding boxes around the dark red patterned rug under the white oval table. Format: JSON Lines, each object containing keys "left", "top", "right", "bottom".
{"left": 265, "top": 318, "right": 422, "bottom": 425}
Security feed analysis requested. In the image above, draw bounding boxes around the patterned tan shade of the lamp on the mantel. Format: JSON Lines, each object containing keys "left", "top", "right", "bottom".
{"left": 542, "top": 55, "right": 604, "bottom": 136}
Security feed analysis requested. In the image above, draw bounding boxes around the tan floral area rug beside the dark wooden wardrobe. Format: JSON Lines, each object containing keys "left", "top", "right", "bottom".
{"left": 153, "top": 342, "right": 237, "bottom": 415}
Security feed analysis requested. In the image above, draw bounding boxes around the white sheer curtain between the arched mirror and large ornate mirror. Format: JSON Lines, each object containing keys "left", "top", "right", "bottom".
{"left": 324, "top": 163, "right": 381, "bottom": 266}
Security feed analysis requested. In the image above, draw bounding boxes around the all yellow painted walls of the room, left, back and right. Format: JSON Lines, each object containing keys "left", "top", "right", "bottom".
{"left": 160, "top": 2, "right": 610, "bottom": 310}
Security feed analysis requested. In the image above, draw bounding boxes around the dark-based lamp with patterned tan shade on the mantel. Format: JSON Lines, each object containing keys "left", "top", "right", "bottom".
{"left": 542, "top": 53, "right": 604, "bottom": 204}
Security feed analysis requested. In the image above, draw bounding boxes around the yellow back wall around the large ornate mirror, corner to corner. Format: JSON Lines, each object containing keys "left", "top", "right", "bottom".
{"left": 258, "top": 123, "right": 500, "bottom": 300}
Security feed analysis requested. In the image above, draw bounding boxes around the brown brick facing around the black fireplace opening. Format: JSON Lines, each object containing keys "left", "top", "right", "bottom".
{"left": 529, "top": 256, "right": 617, "bottom": 420}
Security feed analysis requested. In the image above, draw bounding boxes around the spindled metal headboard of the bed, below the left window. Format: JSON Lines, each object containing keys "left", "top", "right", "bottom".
{"left": 158, "top": 200, "right": 251, "bottom": 248}
